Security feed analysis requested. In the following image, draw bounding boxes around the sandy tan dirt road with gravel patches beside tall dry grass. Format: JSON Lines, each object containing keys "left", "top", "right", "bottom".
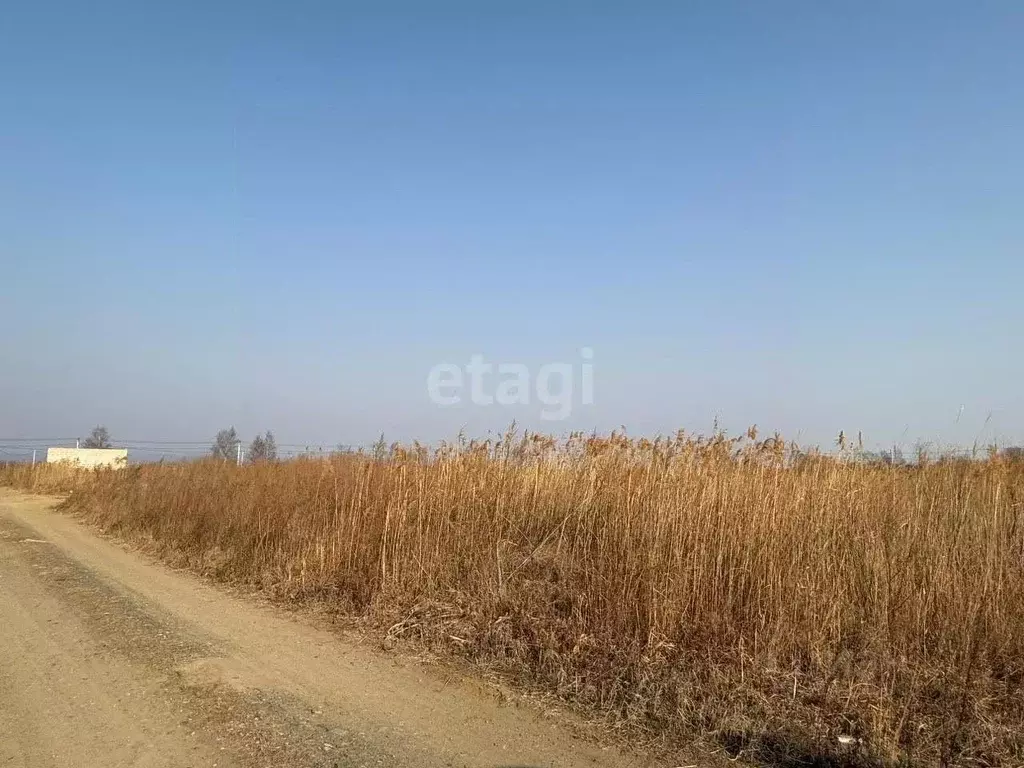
{"left": 0, "top": 489, "right": 646, "bottom": 768}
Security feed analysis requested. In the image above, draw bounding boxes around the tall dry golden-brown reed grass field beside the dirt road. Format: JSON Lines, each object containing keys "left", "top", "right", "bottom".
{"left": 0, "top": 430, "right": 1024, "bottom": 765}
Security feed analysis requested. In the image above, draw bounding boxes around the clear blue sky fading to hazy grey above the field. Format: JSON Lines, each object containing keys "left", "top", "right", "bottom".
{"left": 0, "top": 0, "right": 1024, "bottom": 454}
